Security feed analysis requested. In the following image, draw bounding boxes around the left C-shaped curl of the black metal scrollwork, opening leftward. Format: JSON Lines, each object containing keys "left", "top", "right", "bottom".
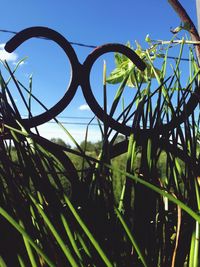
{"left": 5, "top": 27, "right": 81, "bottom": 128}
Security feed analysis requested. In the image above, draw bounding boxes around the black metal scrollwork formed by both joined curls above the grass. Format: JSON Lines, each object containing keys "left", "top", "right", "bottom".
{"left": 5, "top": 27, "right": 200, "bottom": 136}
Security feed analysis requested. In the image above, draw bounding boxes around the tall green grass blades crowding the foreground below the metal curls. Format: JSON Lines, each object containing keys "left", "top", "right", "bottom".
{"left": 0, "top": 34, "right": 200, "bottom": 267}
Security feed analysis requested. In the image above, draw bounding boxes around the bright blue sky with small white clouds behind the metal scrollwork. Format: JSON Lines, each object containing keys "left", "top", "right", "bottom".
{"left": 0, "top": 0, "right": 196, "bottom": 147}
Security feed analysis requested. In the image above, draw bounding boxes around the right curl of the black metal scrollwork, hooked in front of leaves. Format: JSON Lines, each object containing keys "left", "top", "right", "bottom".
{"left": 82, "top": 44, "right": 200, "bottom": 137}
